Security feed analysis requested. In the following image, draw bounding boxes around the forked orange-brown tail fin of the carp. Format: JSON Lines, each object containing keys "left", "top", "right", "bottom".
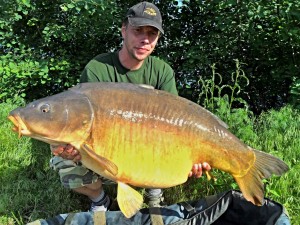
{"left": 234, "top": 149, "right": 289, "bottom": 205}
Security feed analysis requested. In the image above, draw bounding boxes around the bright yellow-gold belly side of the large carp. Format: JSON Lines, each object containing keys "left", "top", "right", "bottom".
{"left": 84, "top": 117, "right": 193, "bottom": 188}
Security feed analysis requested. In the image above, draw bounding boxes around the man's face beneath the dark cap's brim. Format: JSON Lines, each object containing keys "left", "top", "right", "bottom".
{"left": 122, "top": 24, "right": 159, "bottom": 61}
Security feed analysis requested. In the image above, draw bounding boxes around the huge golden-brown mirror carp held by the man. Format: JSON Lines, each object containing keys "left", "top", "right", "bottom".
{"left": 9, "top": 82, "right": 288, "bottom": 218}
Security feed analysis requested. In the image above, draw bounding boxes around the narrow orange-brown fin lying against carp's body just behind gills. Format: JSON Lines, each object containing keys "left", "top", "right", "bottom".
{"left": 81, "top": 143, "right": 118, "bottom": 176}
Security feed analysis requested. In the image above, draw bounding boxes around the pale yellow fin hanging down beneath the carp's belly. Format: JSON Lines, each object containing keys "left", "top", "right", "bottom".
{"left": 117, "top": 182, "right": 143, "bottom": 218}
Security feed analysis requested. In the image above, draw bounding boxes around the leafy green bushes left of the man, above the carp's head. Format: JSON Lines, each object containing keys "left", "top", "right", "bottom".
{"left": 0, "top": 0, "right": 120, "bottom": 102}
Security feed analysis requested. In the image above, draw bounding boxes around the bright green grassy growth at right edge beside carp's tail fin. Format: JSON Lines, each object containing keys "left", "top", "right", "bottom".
{"left": 255, "top": 106, "right": 300, "bottom": 224}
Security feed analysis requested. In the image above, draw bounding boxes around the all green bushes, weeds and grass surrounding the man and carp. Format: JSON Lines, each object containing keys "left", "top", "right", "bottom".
{"left": 0, "top": 0, "right": 300, "bottom": 225}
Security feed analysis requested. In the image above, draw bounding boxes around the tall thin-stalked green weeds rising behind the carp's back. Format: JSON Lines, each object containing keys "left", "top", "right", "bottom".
{"left": 198, "top": 60, "right": 256, "bottom": 142}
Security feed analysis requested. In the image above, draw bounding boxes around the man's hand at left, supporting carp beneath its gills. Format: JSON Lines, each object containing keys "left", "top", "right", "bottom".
{"left": 50, "top": 144, "right": 81, "bottom": 162}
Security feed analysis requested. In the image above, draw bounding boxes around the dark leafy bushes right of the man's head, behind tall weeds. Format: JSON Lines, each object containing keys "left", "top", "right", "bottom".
{"left": 158, "top": 0, "right": 300, "bottom": 113}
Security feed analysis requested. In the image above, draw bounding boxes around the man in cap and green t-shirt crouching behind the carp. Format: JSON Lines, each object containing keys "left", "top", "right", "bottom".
{"left": 51, "top": 2, "right": 210, "bottom": 211}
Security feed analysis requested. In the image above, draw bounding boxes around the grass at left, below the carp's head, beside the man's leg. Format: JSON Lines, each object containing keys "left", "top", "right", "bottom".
{"left": 0, "top": 103, "right": 88, "bottom": 225}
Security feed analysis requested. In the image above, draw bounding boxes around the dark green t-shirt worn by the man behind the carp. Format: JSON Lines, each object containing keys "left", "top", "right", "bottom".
{"left": 80, "top": 52, "right": 178, "bottom": 95}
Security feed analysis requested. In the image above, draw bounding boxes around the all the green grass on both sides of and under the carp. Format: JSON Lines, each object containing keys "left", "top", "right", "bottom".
{"left": 0, "top": 101, "right": 300, "bottom": 225}
